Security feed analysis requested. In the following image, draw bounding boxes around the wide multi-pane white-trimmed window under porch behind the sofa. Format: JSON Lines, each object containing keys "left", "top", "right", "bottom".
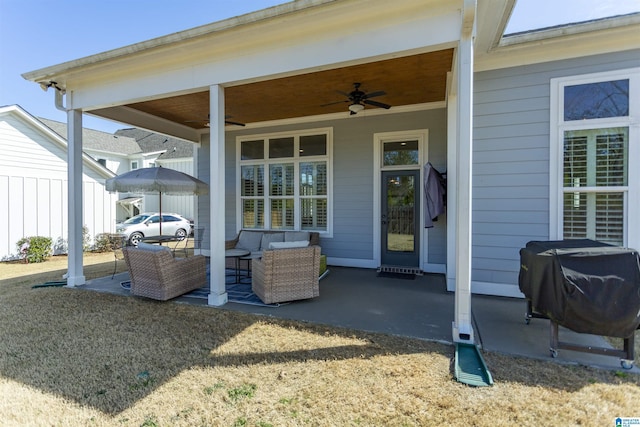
{"left": 237, "top": 129, "right": 332, "bottom": 234}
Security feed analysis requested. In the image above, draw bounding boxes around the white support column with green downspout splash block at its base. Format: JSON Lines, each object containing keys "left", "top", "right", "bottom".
{"left": 453, "top": 0, "right": 475, "bottom": 344}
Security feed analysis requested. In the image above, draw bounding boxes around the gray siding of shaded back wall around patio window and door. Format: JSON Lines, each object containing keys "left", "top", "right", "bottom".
{"left": 198, "top": 109, "right": 447, "bottom": 266}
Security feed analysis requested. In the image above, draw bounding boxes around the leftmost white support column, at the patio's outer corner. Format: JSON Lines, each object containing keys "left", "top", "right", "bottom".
{"left": 67, "top": 110, "right": 85, "bottom": 287}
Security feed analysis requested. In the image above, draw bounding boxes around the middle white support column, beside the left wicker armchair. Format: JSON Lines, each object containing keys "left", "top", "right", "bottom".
{"left": 209, "top": 85, "right": 227, "bottom": 306}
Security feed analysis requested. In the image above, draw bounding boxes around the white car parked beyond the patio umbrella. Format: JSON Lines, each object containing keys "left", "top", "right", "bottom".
{"left": 116, "top": 212, "right": 191, "bottom": 246}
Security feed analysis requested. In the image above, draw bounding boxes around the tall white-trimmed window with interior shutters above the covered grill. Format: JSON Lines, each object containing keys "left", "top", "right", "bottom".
{"left": 551, "top": 70, "right": 640, "bottom": 246}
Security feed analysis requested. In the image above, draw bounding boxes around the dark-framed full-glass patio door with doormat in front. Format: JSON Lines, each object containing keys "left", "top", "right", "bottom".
{"left": 380, "top": 170, "right": 420, "bottom": 267}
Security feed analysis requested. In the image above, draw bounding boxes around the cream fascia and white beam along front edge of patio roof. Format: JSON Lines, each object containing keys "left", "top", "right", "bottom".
{"left": 23, "top": 0, "right": 460, "bottom": 113}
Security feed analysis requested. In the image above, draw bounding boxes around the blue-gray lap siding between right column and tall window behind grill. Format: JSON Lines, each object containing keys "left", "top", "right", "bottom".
{"left": 472, "top": 46, "right": 640, "bottom": 295}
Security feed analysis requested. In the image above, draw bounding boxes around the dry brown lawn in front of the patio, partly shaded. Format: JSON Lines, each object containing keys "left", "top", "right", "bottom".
{"left": 0, "top": 254, "right": 640, "bottom": 427}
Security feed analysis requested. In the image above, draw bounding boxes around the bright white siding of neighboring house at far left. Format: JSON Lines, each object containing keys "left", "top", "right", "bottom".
{"left": 0, "top": 111, "right": 115, "bottom": 259}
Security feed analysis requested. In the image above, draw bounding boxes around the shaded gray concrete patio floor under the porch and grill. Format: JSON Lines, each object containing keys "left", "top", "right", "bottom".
{"left": 80, "top": 267, "right": 640, "bottom": 373}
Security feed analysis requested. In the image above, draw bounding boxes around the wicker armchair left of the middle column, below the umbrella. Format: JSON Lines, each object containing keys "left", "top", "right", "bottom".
{"left": 123, "top": 246, "right": 207, "bottom": 301}
